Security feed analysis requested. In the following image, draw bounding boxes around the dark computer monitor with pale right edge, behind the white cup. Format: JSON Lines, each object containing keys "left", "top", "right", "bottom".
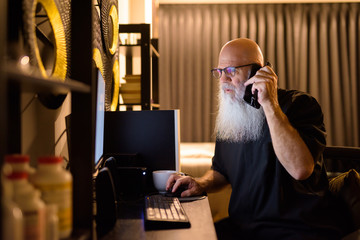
{"left": 104, "top": 110, "right": 180, "bottom": 171}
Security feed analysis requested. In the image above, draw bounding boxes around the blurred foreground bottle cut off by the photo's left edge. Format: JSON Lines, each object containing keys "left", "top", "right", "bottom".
{"left": 1, "top": 174, "right": 24, "bottom": 240}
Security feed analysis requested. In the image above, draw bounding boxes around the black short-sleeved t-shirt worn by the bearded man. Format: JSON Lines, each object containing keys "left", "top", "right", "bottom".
{"left": 212, "top": 89, "right": 344, "bottom": 239}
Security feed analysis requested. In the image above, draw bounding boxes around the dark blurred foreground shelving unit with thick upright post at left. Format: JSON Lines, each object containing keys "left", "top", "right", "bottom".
{"left": 0, "top": 1, "right": 96, "bottom": 239}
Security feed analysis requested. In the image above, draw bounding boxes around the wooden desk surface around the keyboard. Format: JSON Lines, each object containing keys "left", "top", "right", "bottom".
{"left": 101, "top": 197, "right": 217, "bottom": 240}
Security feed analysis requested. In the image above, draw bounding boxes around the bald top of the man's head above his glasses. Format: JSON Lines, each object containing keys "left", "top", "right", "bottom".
{"left": 219, "top": 38, "right": 264, "bottom": 67}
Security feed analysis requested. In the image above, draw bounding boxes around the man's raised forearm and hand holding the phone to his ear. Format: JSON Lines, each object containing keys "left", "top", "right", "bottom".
{"left": 245, "top": 67, "right": 315, "bottom": 180}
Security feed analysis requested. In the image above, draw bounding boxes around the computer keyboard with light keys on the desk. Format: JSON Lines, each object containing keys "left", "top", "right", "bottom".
{"left": 144, "top": 195, "right": 191, "bottom": 230}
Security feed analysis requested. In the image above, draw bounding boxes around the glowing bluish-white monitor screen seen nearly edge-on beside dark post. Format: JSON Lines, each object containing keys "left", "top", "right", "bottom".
{"left": 95, "top": 71, "right": 105, "bottom": 165}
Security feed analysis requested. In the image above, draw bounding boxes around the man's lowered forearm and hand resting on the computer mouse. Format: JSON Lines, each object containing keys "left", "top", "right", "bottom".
{"left": 166, "top": 170, "right": 229, "bottom": 197}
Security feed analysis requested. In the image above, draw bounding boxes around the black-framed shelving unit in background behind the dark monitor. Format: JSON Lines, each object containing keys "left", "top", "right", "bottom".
{"left": 119, "top": 24, "right": 160, "bottom": 110}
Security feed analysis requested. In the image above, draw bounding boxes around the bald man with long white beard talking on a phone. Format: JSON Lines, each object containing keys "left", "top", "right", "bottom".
{"left": 167, "top": 38, "right": 342, "bottom": 240}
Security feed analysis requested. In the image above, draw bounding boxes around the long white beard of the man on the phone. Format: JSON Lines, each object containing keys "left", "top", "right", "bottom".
{"left": 215, "top": 83, "right": 265, "bottom": 142}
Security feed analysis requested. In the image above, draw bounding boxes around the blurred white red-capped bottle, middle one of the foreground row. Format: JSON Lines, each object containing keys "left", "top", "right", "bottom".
{"left": 8, "top": 172, "right": 45, "bottom": 240}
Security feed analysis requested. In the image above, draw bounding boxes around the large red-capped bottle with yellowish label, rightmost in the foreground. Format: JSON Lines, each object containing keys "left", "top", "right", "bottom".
{"left": 31, "top": 156, "right": 72, "bottom": 238}
